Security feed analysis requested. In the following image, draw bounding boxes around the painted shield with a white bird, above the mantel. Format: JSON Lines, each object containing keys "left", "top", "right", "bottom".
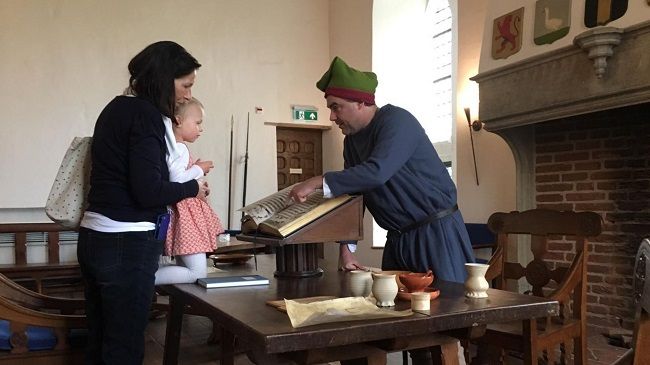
{"left": 533, "top": 0, "right": 571, "bottom": 45}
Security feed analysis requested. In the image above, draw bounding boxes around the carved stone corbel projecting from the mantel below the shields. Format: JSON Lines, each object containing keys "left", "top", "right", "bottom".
{"left": 573, "top": 27, "right": 623, "bottom": 79}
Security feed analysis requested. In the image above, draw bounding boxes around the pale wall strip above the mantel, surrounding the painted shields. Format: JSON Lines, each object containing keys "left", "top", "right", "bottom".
{"left": 479, "top": 0, "right": 650, "bottom": 72}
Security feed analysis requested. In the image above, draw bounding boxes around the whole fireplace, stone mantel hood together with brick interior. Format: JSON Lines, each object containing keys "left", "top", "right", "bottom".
{"left": 473, "top": 22, "right": 650, "bottom": 329}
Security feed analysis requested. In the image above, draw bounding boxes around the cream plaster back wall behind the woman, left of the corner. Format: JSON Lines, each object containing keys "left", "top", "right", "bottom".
{"left": 0, "top": 0, "right": 331, "bottom": 228}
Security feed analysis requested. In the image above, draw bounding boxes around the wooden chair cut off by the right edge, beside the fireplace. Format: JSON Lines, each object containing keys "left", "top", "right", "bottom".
{"left": 613, "top": 238, "right": 650, "bottom": 365}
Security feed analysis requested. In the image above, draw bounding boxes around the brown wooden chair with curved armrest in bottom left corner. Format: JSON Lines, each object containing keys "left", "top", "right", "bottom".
{"left": 0, "top": 274, "right": 86, "bottom": 365}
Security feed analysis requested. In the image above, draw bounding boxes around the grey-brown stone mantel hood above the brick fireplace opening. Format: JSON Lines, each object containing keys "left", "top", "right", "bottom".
{"left": 471, "top": 21, "right": 650, "bottom": 134}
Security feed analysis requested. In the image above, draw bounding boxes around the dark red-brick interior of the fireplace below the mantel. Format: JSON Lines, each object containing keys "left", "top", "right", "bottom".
{"left": 534, "top": 103, "right": 650, "bottom": 329}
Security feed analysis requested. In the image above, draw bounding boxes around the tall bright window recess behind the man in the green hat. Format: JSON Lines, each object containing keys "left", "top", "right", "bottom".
{"left": 372, "top": 0, "right": 454, "bottom": 247}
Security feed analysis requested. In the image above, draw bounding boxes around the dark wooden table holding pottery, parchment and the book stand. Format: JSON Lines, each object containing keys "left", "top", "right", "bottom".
{"left": 164, "top": 255, "right": 559, "bottom": 365}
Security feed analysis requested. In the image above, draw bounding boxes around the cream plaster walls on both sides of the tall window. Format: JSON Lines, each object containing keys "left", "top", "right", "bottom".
{"left": 0, "top": 0, "right": 514, "bottom": 266}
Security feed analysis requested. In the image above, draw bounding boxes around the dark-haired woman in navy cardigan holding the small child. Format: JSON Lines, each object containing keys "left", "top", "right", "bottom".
{"left": 77, "top": 41, "right": 209, "bottom": 365}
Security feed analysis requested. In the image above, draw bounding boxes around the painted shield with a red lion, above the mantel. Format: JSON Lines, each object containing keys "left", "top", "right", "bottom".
{"left": 492, "top": 8, "right": 524, "bottom": 60}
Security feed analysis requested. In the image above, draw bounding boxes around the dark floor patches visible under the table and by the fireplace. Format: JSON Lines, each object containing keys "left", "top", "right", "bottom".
{"left": 144, "top": 315, "right": 626, "bottom": 365}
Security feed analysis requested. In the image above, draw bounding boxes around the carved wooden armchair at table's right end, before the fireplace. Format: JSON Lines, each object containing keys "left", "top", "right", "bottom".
{"left": 478, "top": 209, "right": 601, "bottom": 364}
